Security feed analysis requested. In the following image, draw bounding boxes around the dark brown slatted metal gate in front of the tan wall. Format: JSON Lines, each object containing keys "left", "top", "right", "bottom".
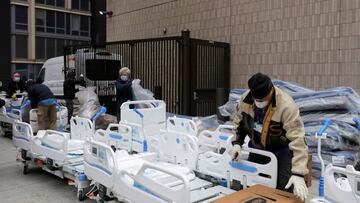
{"left": 64, "top": 31, "right": 230, "bottom": 116}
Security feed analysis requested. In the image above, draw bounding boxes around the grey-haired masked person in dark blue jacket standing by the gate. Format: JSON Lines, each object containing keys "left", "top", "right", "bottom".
{"left": 116, "top": 67, "right": 133, "bottom": 121}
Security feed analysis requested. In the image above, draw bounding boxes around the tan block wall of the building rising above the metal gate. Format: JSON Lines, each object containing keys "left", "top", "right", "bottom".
{"left": 107, "top": 0, "right": 360, "bottom": 91}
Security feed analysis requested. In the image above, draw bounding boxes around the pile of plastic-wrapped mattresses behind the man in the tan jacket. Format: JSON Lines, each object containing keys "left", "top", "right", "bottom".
{"left": 219, "top": 80, "right": 360, "bottom": 173}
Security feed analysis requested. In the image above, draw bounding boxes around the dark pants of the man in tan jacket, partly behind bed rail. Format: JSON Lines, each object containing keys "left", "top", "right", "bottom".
{"left": 248, "top": 148, "right": 293, "bottom": 193}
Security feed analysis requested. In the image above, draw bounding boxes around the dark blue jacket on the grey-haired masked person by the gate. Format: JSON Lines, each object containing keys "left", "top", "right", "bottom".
{"left": 116, "top": 78, "right": 133, "bottom": 108}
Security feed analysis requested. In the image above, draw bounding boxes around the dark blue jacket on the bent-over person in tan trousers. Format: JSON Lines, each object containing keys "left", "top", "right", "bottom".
{"left": 27, "top": 84, "right": 55, "bottom": 108}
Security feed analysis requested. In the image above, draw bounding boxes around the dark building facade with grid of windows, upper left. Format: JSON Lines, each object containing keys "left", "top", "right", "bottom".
{"left": 0, "top": 0, "right": 106, "bottom": 81}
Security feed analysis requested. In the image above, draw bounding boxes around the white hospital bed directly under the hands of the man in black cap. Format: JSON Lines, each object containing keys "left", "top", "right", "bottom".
{"left": 165, "top": 117, "right": 277, "bottom": 188}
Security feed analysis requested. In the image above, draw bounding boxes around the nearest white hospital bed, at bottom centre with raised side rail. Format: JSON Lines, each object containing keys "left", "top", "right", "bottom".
{"left": 84, "top": 138, "right": 234, "bottom": 203}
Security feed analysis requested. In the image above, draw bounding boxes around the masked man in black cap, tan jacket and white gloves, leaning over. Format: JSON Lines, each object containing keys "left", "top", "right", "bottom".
{"left": 232, "top": 73, "right": 309, "bottom": 200}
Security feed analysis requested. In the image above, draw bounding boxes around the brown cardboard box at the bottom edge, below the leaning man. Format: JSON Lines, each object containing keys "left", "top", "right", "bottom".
{"left": 212, "top": 185, "right": 303, "bottom": 203}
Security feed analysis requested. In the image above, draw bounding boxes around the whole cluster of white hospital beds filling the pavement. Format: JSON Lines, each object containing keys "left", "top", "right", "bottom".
{"left": 9, "top": 100, "right": 277, "bottom": 203}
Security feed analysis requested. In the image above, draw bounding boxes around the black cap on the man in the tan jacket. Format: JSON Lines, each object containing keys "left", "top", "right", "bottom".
{"left": 248, "top": 73, "right": 273, "bottom": 99}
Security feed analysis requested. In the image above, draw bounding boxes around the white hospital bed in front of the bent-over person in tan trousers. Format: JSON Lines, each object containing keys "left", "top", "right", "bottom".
{"left": 13, "top": 109, "right": 106, "bottom": 200}
